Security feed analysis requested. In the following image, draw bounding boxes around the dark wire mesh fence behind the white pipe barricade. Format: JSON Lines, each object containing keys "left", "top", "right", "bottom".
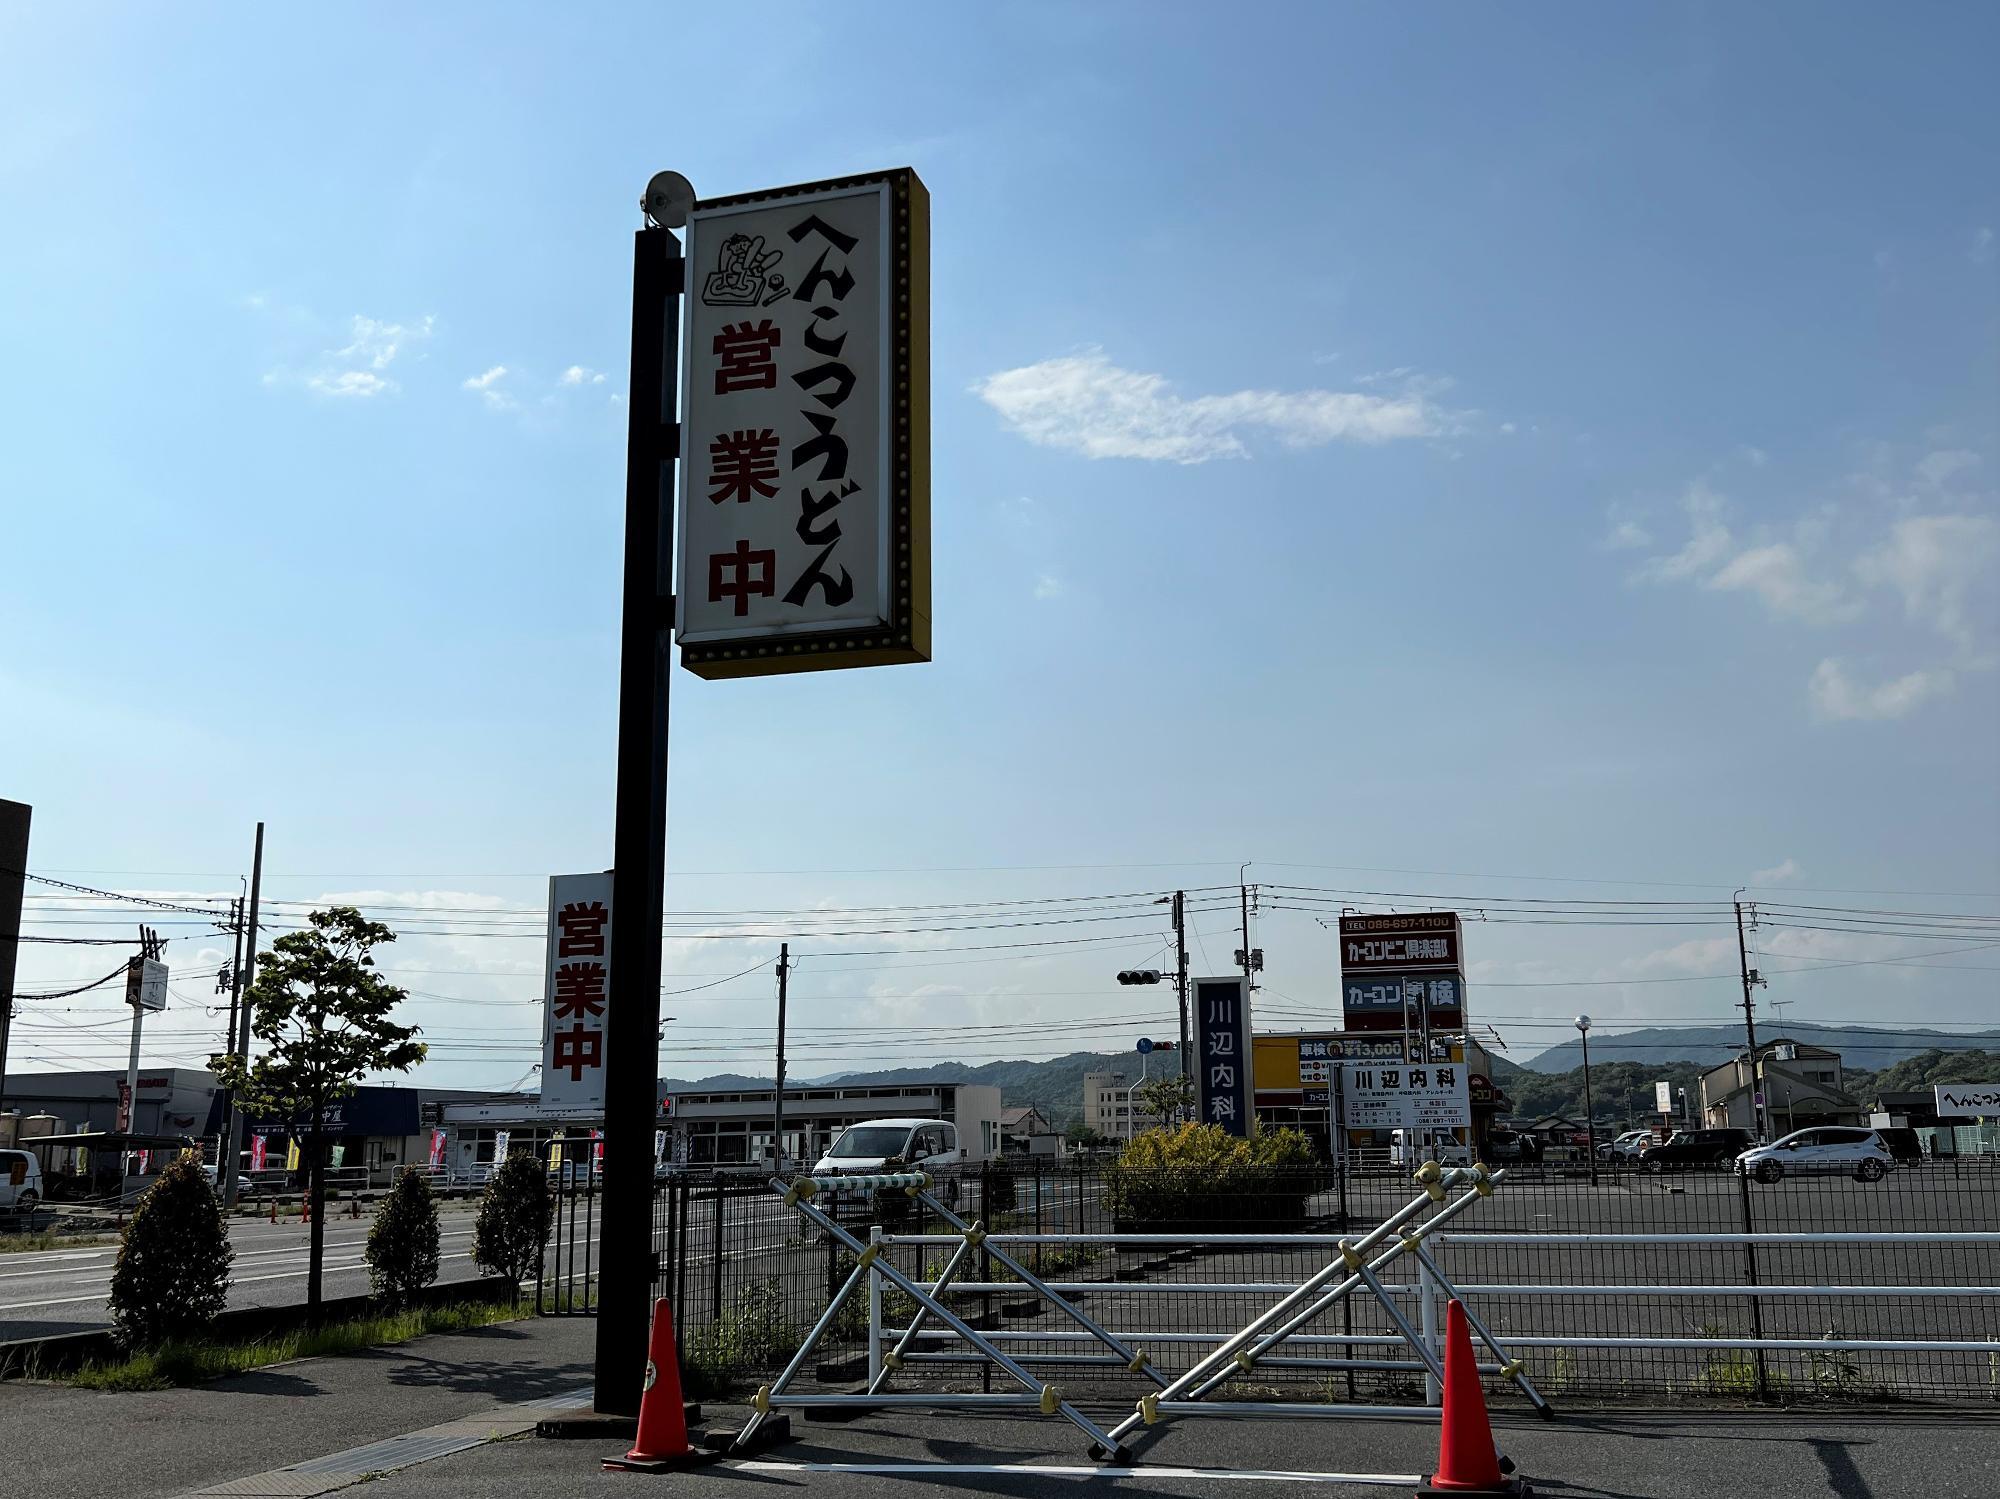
{"left": 596, "top": 1157, "right": 2000, "bottom": 1403}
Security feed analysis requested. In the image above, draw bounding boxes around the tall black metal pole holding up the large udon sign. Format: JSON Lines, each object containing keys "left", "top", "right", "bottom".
{"left": 594, "top": 216, "right": 686, "bottom": 1415}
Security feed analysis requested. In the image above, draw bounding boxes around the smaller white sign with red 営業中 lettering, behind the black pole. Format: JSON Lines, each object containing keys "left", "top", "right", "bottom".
{"left": 542, "top": 871, "right": 612, "bottom": 1119}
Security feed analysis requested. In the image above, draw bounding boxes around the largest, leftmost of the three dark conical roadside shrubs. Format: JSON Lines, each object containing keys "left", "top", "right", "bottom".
{"left": 110, "top": 1151, "right": 236, "bottom": 1345}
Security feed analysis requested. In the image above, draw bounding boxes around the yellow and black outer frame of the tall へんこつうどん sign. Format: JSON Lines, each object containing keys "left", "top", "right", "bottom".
{"left": 680, "top": 166, "right": 930, "bottom": 682}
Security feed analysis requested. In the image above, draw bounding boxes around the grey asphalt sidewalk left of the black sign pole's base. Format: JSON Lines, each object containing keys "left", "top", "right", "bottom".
{"left": 0, "top": 1317, "right": 596, "bottom": 1499}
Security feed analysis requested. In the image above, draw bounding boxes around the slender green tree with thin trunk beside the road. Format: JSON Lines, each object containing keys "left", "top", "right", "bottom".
{"left": 208, "top": 905, "right": 426, "bottom": 1323}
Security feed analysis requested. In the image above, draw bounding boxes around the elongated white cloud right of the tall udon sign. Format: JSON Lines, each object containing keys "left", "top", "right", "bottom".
{"left": 972, "top": 350, "right": 1450, "bottom": 464}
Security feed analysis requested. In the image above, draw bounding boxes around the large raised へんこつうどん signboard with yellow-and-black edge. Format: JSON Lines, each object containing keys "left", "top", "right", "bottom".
{"left": 676, "top": 168, "right": 930, "bottom": 678}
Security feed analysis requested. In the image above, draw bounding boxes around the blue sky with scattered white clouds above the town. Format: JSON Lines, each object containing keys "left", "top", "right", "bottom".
{"left": 0, "top": 4, "right": 2000, "bottom": 1081}
